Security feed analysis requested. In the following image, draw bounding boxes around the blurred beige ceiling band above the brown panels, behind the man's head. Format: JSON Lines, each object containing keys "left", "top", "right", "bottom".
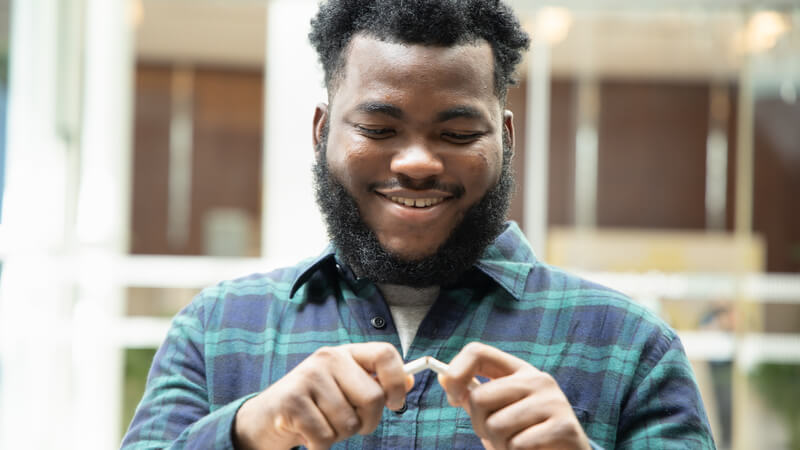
{"left": 136, "top": 0, "right": 800, "bottom": 79}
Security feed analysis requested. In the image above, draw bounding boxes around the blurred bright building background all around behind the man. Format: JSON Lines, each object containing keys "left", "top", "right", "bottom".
{"left": 0, "top": 0, "right": 800, "bottom": 449}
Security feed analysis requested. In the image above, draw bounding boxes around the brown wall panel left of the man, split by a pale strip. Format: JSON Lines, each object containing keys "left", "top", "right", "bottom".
{"left": 131, "top": 63, "right": 263, "bottom": 256}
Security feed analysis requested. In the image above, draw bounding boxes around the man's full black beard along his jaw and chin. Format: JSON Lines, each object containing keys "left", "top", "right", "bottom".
{"left": 314, "top": 132, "right": 514, "bottom": 288}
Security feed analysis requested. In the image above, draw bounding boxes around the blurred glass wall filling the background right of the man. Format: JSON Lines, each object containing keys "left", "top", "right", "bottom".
{"left": 511, "top": 2, "right": 800, "bottom": 448}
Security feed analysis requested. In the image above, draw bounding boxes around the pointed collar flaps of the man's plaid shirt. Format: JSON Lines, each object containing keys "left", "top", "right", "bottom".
{"left": 289, "top": 221, "right": 537, "bottom": 300}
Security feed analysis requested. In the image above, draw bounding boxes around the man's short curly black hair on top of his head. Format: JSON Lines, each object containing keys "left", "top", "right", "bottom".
{"left": 308, "top": 0, "right": 530, "bottom": 102}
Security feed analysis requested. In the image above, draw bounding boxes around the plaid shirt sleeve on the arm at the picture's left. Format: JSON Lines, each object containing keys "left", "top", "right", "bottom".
{"left": 122, "top": 301, "right": 255, "bottom": 449}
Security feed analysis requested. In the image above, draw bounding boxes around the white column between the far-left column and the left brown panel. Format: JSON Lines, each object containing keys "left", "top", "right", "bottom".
{"left": 70, "top": 0, "right": 133, "bottom": 449}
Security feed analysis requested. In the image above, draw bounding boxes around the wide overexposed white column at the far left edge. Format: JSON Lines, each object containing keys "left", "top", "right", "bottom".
{"left": 0, "top": 0, "right": 80, "bottom": 449}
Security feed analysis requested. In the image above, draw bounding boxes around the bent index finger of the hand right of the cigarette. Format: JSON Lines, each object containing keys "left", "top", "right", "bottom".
{"left": 440, "top": 342, "right": 536, "bottom": 406}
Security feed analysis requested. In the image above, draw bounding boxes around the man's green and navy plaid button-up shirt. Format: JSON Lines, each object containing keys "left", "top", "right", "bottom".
{"left": 123, "top": 223, "right": 714, "bottom": 449}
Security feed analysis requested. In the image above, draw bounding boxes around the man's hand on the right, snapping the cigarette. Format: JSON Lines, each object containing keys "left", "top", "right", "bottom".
{"left": 439, "top": 342, "right": 590, "bottom": 450}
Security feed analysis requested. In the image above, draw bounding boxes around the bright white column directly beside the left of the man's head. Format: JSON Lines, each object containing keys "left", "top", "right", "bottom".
{"left": 261, "top": 0, "right": 327, "bottom": 264}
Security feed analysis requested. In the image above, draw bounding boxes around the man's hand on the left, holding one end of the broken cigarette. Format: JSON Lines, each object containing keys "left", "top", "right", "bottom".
{"left": 234, "top": 342, "right": 414, "bottom": 450}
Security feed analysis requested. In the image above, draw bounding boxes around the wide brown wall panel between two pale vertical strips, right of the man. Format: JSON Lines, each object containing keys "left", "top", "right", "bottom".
{"left": 597, "top": 81, "right": 709, "bottom": 229}
